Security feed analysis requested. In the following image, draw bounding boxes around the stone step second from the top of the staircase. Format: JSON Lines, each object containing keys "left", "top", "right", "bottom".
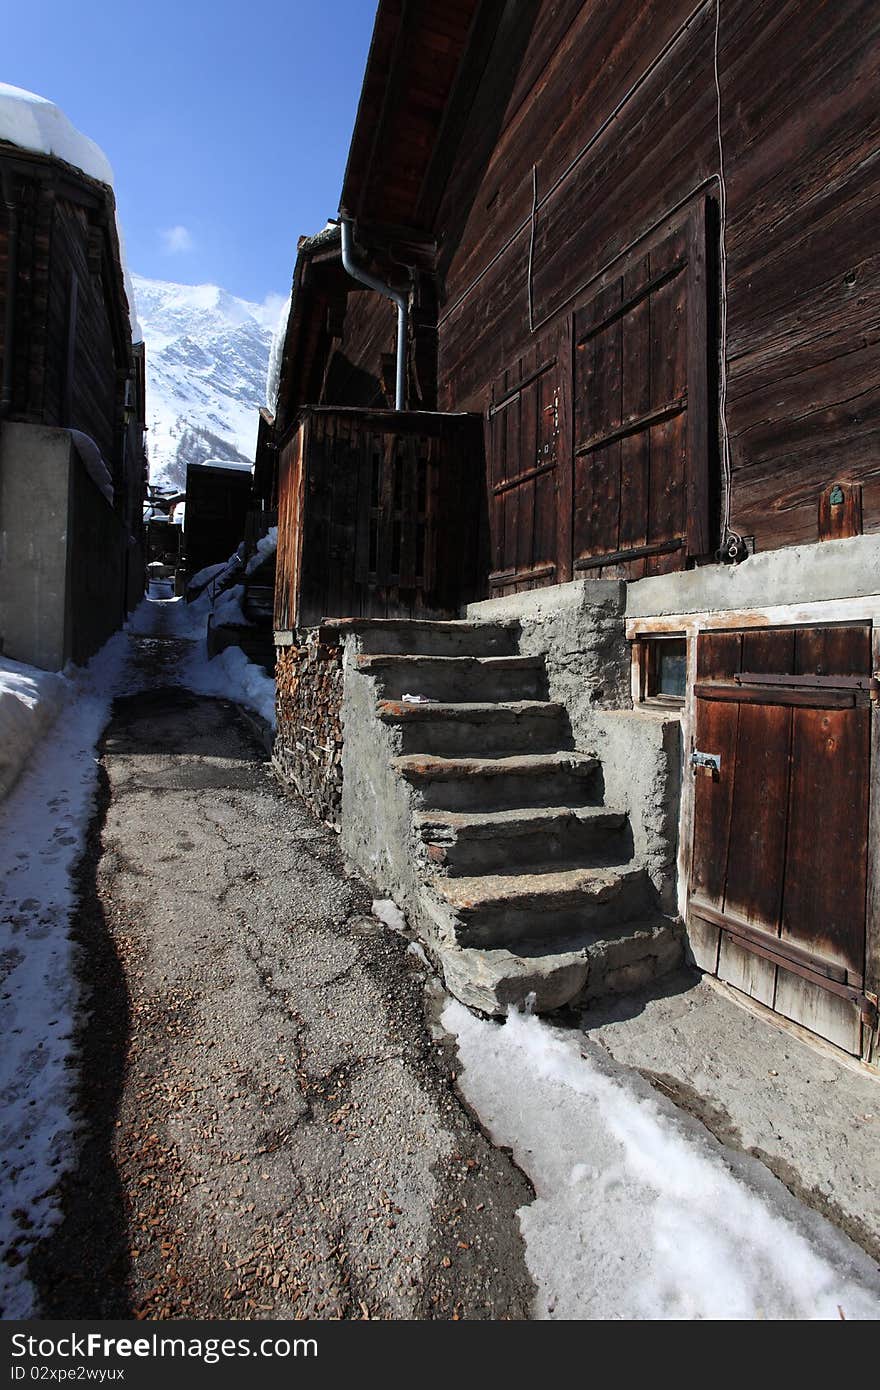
{"left": 357, "top": 653, "right": 546, "bottom": 703}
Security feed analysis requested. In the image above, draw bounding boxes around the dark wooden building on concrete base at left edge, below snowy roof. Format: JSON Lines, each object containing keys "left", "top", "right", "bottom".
{"left": 0, "top": 108, "right": 146, "bottom": 666}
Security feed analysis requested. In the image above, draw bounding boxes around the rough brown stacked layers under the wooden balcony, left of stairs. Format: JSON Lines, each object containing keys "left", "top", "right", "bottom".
{"left": 274, "top": 627, "right": 342, "bottom": 826}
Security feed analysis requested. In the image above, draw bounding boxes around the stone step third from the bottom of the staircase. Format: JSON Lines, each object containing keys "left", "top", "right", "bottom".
{"left": 416, "top": 806, "right": 633, "bottom": 876}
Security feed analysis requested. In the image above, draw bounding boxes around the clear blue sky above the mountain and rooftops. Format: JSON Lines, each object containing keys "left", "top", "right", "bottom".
{"left": 0, "top": 0, "right": 375, "bottom": 300}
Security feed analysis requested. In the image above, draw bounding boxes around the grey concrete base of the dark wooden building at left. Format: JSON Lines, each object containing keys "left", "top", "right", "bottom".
{"left": 0, "top": 421, "right": 128, "bottom": 671}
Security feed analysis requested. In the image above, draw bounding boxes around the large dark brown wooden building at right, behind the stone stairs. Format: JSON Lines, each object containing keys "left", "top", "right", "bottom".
{"left": 274, "top": 0, "right": 880, "bottom": 1055}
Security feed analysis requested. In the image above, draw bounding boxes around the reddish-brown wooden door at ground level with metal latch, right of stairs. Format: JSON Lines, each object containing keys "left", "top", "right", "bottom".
{"left": 688, "top": 624, "right": 872, "bottom": 1054}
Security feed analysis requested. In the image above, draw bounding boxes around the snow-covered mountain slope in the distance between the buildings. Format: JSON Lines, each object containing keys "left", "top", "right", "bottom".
{"left": 132, "top": 275, "right": 281, "bottom": 488}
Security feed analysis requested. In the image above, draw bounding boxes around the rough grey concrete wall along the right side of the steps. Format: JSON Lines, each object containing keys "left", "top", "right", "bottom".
{"left": 467, "top": 580, "right": 681, "bottom": 913}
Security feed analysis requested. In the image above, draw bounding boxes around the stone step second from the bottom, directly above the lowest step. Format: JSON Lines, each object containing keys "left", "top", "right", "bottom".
{"left": 431, "top": 862, "right": 649, "bottom": 948}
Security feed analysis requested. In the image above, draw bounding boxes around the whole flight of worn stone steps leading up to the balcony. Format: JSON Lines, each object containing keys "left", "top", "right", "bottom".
{"left": 341, "top": 620, "right": 683, "bottom": 1013}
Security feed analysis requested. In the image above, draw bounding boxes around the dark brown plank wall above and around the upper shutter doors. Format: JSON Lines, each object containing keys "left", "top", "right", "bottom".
{"left": 330, "top": 0, "right": 880, "bottom": 582}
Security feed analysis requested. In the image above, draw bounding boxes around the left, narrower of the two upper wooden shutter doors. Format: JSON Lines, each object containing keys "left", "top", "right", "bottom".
{"left": 488, "top": 324, "right": 571, "bottom": 595}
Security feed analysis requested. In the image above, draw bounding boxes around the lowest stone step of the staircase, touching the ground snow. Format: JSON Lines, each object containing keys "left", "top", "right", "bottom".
{"left": 428, "top": 905, "right": 684, "bottom": 1016}
